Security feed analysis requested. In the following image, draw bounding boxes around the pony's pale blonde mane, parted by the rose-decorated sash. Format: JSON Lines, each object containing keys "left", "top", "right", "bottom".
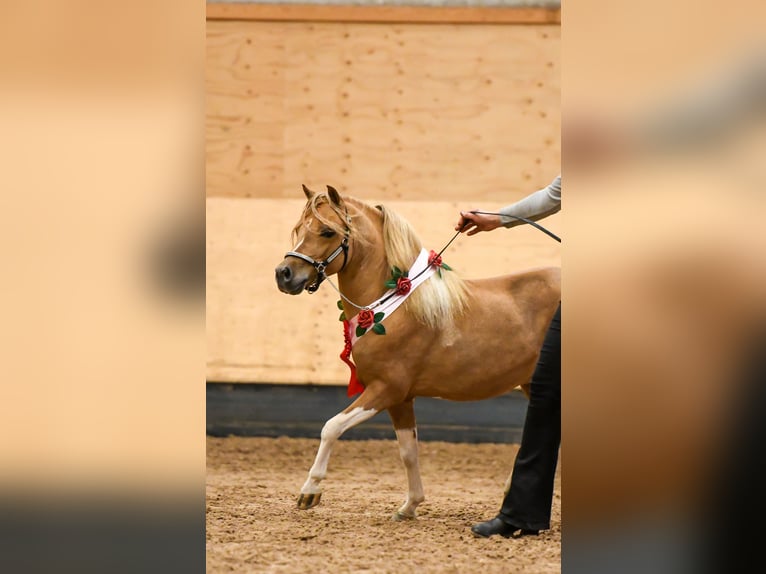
{"left": 376, "top": 205, "right": 467, "bottom": 331}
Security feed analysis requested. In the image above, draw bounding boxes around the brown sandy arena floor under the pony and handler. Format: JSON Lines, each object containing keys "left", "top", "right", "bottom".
{"left": 206, "top": 437, "right": 561, "bottom": 574}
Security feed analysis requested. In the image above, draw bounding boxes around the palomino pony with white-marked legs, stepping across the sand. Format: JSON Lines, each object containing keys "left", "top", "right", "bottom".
{"left": 276, "top": 186, "right": 561, "bottom": 520}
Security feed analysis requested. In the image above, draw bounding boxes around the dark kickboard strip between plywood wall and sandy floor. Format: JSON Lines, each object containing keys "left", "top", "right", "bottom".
{"left": 207, "top": 388, "right": 527, "bottom": 443}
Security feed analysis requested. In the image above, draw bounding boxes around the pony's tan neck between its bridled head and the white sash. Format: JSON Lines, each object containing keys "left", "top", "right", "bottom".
{"left": 338, "top": 209, "right": 390, "bottom": 318}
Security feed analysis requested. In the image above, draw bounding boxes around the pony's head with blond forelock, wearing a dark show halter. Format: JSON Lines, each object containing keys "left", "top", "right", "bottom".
{"left": 275, "top": 185, "right": 351, "bottom": 295}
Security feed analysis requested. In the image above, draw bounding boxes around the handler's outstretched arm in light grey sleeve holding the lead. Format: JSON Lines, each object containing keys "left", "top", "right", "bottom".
{"left": 455, "top": 175, "right": 561, "bottom": 235}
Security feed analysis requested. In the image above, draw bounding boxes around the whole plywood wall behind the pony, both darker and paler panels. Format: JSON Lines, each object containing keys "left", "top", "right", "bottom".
{"left": 206, "top": 15, "right": 560, "bottom": 384}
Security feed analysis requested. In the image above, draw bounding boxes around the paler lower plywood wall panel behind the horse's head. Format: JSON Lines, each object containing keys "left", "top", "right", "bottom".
{"left": 207, "top": 197, "right": 561, "bottom": 384}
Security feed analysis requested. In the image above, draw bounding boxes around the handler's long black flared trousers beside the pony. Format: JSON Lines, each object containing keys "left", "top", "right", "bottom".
{"left": 498, "top": 303, "right": 561, "bottom": 530}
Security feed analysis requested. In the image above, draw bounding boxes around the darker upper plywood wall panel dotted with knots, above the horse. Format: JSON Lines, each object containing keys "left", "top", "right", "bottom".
{"left": 207, "top": 21, "right": 560, "bottom": 203}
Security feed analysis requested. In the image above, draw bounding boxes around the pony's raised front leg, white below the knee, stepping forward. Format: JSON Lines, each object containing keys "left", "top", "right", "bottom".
{"left": 298, "top": 384, "right": 385, "bottom": 510}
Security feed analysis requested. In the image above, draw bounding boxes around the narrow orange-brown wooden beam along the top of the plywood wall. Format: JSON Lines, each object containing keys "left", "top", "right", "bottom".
{"left": 207, "top": 2, "right": 561, "bottom": 25}
